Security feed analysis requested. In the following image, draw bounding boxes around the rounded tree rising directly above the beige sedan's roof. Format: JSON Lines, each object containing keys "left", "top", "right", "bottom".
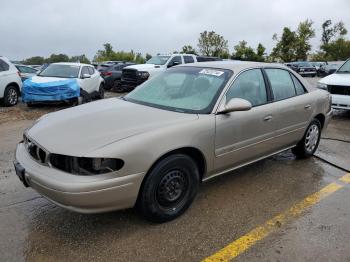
{"left": 198, "top": 31, "right": 228, "bottom": 57}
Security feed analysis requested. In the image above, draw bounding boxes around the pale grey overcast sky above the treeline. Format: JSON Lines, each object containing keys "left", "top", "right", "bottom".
{"left": 0, "top": 0, "right": 350, "bottom": 60}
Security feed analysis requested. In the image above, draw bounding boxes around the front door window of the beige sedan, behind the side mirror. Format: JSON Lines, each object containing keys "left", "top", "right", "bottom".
{"left": 226, "top": 69, "right": 267, "bottom": 106}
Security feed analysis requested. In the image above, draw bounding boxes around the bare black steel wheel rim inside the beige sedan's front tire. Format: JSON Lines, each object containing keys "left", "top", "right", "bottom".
{"left": 157, "top": 170, "right": 187, "bottom": 207}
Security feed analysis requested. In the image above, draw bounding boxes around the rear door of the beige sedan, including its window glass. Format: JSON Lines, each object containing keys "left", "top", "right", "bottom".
{"left": 265, "top": 68, "right": 314, "bottom": 149}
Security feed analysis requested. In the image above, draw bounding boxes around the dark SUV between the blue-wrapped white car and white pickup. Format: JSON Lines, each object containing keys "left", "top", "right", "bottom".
{"left": 97, "top": 62, "right": 134, "bottom": 90}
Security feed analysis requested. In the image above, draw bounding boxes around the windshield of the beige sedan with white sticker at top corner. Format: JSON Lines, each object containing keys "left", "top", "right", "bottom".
{"left": 124, "top": 67, "right": 232, "bottom": 114}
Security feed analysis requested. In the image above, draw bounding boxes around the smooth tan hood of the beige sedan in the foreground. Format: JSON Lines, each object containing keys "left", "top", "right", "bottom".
{"left": 27, "top": 98, "right": 198, "bottom": 156}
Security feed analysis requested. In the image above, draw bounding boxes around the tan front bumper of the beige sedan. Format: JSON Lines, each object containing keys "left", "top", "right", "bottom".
{"left": 15, "top": 143, "right": 145, "bottom": 213}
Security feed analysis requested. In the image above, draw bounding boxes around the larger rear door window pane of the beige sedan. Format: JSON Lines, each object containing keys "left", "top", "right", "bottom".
{"left": 265, "top": 68, "right": 295, "bottom": 101}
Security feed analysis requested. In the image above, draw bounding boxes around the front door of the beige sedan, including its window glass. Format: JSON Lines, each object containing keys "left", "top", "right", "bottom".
{"left": 214, "top": 69, "right": 276, "bottom": 172}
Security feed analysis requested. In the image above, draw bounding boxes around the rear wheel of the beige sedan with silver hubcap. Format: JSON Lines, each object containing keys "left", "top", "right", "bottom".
{"left": 292, "top": 119, "right": 321, "bottom": 158}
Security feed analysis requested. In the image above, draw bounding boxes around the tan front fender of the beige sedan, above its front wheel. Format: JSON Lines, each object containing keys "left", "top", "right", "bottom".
{"left": 86, "top": 114, "right": 215, "bottom": 180}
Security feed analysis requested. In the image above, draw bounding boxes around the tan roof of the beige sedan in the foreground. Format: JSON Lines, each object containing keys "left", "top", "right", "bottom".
{"left": 179, "top": 60, "right": 288, "bottom": 72}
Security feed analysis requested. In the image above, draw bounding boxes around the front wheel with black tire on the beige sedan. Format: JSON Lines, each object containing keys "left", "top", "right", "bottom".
{"left": 137, "top": 154, "right": 199, "bottom": 223}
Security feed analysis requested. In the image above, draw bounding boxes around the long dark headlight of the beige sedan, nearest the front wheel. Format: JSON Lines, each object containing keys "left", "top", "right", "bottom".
{"left": 50, "top": 154, "right": 124, "bottom": 176}
